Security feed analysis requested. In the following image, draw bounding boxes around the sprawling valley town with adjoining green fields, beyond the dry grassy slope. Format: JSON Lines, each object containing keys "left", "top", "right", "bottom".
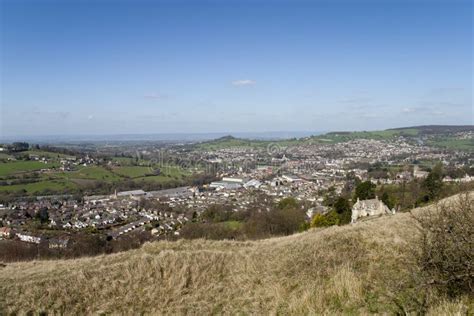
{"left": 0, "top": 125, "right": 474, "bottom": 260}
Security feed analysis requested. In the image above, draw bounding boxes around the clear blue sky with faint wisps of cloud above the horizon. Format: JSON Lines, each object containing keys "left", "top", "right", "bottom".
{"left": 0, "top": 0, "right": 474, "bottom": 137}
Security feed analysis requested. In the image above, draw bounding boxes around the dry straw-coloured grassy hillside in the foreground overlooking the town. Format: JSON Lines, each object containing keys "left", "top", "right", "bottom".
{"left": 0, "top": 194, "right": 473, "bottom": 315}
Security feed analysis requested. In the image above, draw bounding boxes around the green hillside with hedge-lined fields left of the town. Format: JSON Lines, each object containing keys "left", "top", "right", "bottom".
{"left": 0, "top": 149, "right": 191, "bottom": 201}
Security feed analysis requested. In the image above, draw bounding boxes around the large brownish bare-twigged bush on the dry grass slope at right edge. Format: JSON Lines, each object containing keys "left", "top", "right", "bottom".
{"left": 416, "top": 193, "right": 474, "bottom": 298}
